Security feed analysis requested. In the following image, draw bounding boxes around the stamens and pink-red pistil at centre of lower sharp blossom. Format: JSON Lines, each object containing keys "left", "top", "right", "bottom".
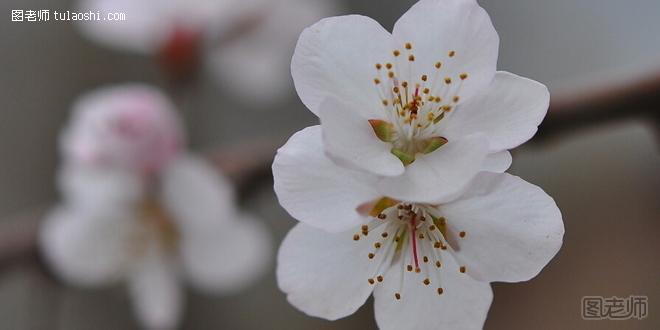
{"left": 353, "top": 197, "right": 467, "bottom": 300}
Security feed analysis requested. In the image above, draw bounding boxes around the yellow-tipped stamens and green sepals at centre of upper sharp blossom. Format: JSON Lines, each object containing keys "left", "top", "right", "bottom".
{"left": 369, "top": 42, "right": 468, "bottom": 165}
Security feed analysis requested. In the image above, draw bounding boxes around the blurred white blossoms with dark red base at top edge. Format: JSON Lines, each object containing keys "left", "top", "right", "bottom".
{"left": 78, "top": 0, "right": 337, "bottom": 102}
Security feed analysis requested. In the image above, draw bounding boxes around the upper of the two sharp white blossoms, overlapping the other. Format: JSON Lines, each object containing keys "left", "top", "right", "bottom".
{"left": 291, "top": 0, "right": 549, "bottom": 202}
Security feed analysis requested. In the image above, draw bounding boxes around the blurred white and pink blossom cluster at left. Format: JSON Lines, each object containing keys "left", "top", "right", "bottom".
{"left": 40, "top": 85, "right": 270, "bottom": 329}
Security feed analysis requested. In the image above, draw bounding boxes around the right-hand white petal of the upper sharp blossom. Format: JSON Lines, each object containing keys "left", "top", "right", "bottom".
{"left": 444, "top": 72, "right": 550, "bottom": 151}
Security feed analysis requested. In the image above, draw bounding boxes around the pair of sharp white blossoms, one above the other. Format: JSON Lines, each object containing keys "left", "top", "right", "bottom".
{"left": 273, "top": 0, "right": 564, "bottom": 329}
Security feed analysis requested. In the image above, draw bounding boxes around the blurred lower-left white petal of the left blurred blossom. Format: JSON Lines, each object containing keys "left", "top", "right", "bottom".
{"left": 39, "top": 208, "right": 134, "bottom": 286}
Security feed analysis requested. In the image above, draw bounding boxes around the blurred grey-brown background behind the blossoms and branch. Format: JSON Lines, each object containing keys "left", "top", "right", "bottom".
{"left": 0, "top": 0, "right": 660, "bottom": 330}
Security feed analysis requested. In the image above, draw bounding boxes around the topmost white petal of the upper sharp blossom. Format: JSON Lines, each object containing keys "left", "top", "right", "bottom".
{"left": 392, "top": 0, "right": 499, "bottom": 100}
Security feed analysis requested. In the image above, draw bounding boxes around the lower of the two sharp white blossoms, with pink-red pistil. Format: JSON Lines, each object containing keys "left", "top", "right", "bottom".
{"left": 273, "top": 126, "right": 564, "bottom": 330}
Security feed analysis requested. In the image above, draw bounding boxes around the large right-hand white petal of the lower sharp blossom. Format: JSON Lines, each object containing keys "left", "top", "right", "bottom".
{"left": 440, "top": 173, "right": 564, "bottom": 282}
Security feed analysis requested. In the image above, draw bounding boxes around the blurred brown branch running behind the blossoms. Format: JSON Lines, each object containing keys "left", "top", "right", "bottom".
{"left": 5, "top": 70, "right": 660, "bottom": 270}
